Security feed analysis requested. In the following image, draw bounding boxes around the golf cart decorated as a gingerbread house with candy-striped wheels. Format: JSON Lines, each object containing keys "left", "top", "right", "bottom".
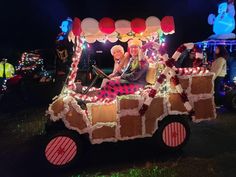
{"left": 44, "top": 16, "right": 216, "bottom": 167}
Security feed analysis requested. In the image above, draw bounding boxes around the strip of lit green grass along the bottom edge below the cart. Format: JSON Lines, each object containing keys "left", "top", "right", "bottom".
{"left": 72, "top": 166, "right": 177, "bottom": 177}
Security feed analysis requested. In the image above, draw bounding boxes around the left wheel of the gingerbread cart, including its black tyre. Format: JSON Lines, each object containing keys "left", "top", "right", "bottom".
{"left": 44, "top": 131, "right": 83, "bottom": 168}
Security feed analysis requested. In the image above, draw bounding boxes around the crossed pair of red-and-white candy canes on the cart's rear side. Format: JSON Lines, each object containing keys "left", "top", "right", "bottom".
{"left": 139, "top": 43, "right": 203, "bottom": 118}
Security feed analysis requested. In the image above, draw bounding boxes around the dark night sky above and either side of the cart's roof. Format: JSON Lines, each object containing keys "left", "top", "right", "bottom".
{"left": 0, "top": 0, "right": 217, "bottom": 57}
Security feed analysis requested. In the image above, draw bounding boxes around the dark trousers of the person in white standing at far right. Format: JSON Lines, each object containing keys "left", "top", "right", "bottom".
{"left": 214, "top": 77, "right": 224, "bottom": 105}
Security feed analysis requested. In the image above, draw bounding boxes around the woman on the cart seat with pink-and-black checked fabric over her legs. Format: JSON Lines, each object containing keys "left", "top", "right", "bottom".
{"left": 98, "top": 39, "right": 148, "bottom": 99}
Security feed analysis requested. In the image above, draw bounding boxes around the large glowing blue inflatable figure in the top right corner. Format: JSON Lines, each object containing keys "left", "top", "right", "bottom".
{"left": 208, "top": 2, "right": 235, "bottom": 39}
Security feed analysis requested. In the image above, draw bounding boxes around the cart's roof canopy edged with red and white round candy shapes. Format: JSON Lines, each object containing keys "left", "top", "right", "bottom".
{"left": 68, "top": 16, "right": 175, "bottom": 43}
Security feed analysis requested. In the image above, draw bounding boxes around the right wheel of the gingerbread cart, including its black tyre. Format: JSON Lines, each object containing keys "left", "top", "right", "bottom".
{"left": 156, "top": 116, "right": 190, "bottom": 151}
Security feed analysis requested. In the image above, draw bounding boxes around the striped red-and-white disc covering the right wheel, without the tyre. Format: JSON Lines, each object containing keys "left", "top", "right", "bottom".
{"left": 162, "top": 122, "right": 186, "bottom": 147}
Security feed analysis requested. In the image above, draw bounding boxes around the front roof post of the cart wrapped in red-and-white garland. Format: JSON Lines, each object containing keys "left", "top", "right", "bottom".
{"left": 68, "top": 37, "right": 82, "bottom": 90}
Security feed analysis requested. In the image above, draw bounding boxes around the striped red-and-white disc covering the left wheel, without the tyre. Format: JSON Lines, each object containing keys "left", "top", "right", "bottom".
{"left": 45, "top": 135, "right": 79, "bottom": 166}
